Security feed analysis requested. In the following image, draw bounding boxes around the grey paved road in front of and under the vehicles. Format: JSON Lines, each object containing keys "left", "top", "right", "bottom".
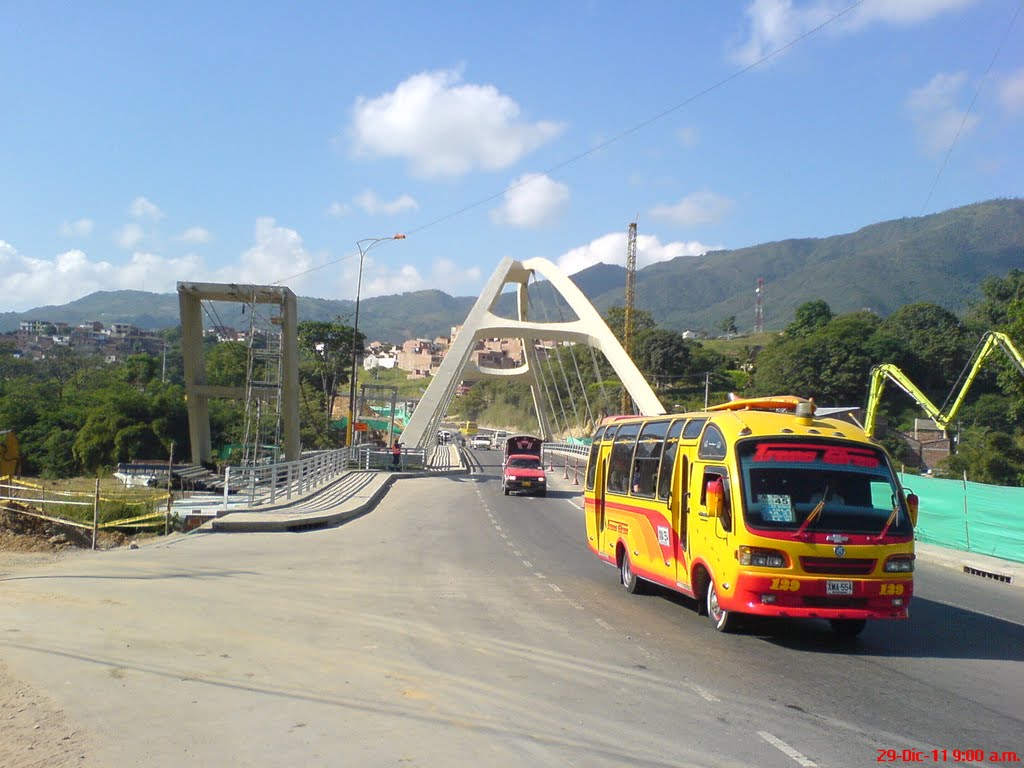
{"left": 0, "top": 452, "right": 1024, "bottom": 768}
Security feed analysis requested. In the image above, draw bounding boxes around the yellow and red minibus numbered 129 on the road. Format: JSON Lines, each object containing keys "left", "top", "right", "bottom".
{"left": 584, "top": 395, "right": 918, "bottom": 637}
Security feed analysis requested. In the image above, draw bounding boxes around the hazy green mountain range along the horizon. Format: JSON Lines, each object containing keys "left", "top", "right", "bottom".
{"left": 0, "top": 199, "right": 1024, "bottom": 342}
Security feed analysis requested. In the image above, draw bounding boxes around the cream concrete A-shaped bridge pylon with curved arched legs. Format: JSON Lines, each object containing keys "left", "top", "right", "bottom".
{"left": 401, "top": 257, "right": 665, "bottom": 447}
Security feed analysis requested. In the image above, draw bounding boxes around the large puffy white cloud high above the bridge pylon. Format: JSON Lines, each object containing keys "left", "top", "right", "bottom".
{"left": 351, "top": 70, "right": 564, "bottom": 176}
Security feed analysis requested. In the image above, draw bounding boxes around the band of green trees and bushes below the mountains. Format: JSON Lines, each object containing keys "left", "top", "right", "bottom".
{"left": 6, "top": 269, "right": 1024, "bottom": 485}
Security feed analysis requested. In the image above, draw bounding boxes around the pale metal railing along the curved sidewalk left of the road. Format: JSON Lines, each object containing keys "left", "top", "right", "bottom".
{"left": 224, "top": 447, "right": 350, "bottom": 510}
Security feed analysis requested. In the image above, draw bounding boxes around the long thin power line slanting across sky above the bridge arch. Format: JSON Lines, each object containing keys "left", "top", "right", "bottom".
{"left": 270, "top": 0, "right": 860, "bottom": 286}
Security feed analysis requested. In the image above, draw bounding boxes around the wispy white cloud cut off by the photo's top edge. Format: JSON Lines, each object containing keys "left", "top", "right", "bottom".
{"left": 732, "top": 0, "right": 978, "bottom": 66}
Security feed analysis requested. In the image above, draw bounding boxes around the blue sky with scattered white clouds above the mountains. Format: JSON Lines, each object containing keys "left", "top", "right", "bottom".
{"left": 0, "top": 0, "right": 1024, "bottom": 310}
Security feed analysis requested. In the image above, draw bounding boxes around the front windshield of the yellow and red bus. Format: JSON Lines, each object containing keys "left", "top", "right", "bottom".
{"left": 738, "top": 439, "right": 912, "bottom": 536}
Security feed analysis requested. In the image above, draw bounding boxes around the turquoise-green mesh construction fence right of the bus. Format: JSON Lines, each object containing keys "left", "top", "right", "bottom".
{"left": 900, "top": 474, "right": 1024, "bottom": 562}
